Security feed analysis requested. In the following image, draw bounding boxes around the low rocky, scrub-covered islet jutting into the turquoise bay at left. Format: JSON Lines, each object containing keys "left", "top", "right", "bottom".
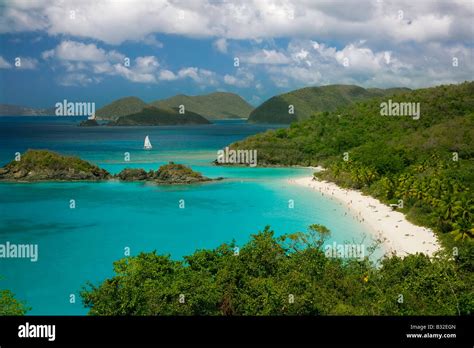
{"left": 0, "top": 150, "right": 218, "bottom": 184}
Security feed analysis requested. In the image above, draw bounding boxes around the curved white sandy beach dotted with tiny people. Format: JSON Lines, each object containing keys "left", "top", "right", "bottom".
{"left": 288, "top": 177, "right": 440, "bottom": 256}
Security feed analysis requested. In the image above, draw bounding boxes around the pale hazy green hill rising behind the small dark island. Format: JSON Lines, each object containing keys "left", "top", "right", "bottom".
{"left": 151, "top": 92, "right": 253, "bottom": 120}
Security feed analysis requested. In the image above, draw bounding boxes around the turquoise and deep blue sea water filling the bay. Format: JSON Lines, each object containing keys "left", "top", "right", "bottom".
{"left": 0, "top": 117, "right": 374, "bottom": 315}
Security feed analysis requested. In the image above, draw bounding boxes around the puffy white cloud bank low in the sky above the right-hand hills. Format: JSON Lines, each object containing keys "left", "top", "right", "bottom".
{"left": 264, "top": 40, "right": 474, "bottom": 88}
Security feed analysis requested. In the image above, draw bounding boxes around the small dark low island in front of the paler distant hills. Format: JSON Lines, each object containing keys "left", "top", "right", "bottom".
{"left": 108, "top": 106, "right": 211, "bottom": 126}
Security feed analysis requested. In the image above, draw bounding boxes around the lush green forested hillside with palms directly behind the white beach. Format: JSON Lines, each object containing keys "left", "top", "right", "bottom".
{"left": 231, "top": 82, "right": 474, "bottom": 245}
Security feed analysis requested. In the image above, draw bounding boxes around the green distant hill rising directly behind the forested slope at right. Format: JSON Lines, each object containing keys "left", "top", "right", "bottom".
{"left": 248, "top": 85, "right": 409, "bottom": 124}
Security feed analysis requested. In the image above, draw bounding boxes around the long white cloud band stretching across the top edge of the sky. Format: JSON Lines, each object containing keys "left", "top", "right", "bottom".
{"left": 0, "top": 0, "right": 474, "bottom": 44}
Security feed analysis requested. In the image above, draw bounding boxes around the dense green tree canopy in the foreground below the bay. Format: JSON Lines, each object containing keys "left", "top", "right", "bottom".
{"left": 81, "top": 225, "right": 474, "bottom": 315}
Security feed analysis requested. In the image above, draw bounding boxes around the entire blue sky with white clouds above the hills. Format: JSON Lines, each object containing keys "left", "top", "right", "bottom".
{"left": 0, "top": 0, "right": 474, "bottom": 107}
